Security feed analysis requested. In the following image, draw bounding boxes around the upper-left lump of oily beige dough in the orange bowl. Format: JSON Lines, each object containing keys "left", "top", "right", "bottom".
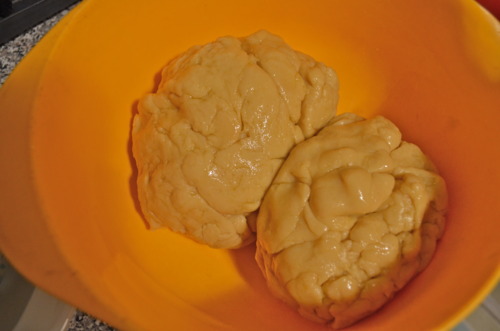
{"left": 132, "top": 31, "right": 338, "bottom": 248}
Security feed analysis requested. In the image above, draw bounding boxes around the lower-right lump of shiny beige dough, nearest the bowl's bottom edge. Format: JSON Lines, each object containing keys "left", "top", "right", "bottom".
{"left": 256, "top": 113, "right": 447, "bottom": 328}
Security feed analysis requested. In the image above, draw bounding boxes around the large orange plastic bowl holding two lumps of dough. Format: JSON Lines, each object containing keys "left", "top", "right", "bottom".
{"left": 0, "top": 0, "right": 500, "bottom": 331}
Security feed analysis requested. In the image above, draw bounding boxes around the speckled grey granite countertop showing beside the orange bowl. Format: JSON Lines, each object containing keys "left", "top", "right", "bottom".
{"left": 0, "top": 6, "right": 115, "bottom": 331}
